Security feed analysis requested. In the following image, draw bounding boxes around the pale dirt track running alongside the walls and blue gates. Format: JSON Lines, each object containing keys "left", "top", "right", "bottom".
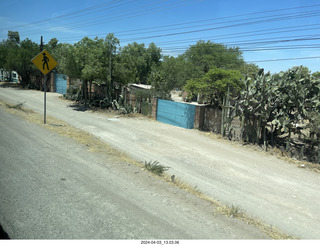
{"left": 0, "top": 85, "right": 320, "bottom": 239}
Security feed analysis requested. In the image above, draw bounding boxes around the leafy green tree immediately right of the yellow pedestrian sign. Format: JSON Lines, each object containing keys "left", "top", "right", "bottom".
{"left": 63, "top": 34, "right": 119, "bottom": 103}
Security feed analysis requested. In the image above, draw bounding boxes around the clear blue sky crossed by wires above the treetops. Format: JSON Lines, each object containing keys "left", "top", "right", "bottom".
{"left": 0, "top": 0, "right": 320, "bottom": 73}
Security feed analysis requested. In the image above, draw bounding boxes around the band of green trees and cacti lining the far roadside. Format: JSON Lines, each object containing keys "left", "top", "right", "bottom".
{"left": 0, "top": 31, "right": 320, "bottom": 164}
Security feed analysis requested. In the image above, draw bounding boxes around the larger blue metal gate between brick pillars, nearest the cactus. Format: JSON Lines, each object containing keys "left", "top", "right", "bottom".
{"left": 157, "top": 99, "right": 196, "bottom": 129}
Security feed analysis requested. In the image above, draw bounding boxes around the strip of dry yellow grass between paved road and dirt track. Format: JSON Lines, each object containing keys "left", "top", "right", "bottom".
{"left": 0, "top": 100, "right": 295, "bottom": 239}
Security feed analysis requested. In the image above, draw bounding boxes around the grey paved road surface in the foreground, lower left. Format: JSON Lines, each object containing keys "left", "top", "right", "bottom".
{"left": 0, "top": 106, "right": 266, "bottom": 239}
